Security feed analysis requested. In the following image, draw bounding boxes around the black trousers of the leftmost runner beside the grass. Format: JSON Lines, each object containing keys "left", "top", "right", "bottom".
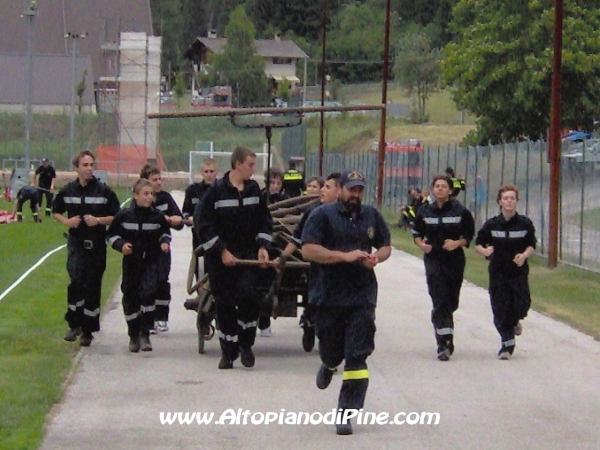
{"left": 65, "top": 236, "right": 106, "bottom": 335}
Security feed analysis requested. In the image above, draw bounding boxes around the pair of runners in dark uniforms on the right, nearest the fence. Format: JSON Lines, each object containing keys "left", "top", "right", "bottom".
{"left": 411, "top": 170, "right": 536, "bottom": 361}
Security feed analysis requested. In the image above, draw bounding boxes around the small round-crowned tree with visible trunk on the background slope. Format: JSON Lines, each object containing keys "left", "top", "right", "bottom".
{"left": 394, "top": 28, "right": 441, "bottom": 122}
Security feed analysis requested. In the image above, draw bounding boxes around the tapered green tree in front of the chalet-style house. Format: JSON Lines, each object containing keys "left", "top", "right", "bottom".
{"left": 213, "top": 6, "right": 268, "bottom": 106}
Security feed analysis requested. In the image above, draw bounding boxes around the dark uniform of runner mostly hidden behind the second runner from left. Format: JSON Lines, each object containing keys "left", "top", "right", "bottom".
{"left": 153, "top": 191, "right": 184, "bottom": 322}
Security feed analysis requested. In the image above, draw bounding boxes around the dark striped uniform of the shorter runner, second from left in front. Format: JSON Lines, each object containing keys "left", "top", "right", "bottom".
{"left": 107, "top": 201, "right": 171, "bottom": 337}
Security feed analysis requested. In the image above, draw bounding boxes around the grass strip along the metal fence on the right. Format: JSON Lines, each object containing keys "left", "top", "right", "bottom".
{"left": 386, "top": 212, "right": 600, "bottom": 340}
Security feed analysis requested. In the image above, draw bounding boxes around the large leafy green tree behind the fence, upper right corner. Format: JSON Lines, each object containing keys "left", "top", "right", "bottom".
{"left": 442, "top": 0, "right": 600, "bottom": 143}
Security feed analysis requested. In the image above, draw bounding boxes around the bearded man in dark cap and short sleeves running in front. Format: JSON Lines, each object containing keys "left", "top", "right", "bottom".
{"left": 302, "top": 170, "right": 391, "bottom": 435}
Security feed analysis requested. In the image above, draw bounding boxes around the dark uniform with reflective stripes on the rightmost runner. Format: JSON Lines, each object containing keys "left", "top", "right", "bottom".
{"left": 475, "top": 213, "right": 537, "bottom": 354}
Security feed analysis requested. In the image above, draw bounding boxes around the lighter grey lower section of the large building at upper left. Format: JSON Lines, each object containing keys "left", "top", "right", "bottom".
{"left": 0, "top": 54, "right": 95, "bottom": 105}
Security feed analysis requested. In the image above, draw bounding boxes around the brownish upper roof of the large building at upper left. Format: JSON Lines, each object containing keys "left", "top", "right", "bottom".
{"left": 0, "top": 0, "right": 152, "bottom": 80}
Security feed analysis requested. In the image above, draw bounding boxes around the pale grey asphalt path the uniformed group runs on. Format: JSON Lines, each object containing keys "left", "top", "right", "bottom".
{"left": 41, "top": 193, "right": 600, "bottom": 450}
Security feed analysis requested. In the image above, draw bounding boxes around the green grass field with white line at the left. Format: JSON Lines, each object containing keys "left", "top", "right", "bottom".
{"left": 0, "top": 191, "right": 126, "bottom": 450}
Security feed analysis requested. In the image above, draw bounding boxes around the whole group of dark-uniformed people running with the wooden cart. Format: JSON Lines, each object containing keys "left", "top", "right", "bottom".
{"left": 47, "top": 147, "right": 536, "bottom": 435}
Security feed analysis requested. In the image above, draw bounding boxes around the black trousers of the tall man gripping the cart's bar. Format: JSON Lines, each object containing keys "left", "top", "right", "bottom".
{"left": 208, "top": 266, "right": 260, "bottom": 361}
